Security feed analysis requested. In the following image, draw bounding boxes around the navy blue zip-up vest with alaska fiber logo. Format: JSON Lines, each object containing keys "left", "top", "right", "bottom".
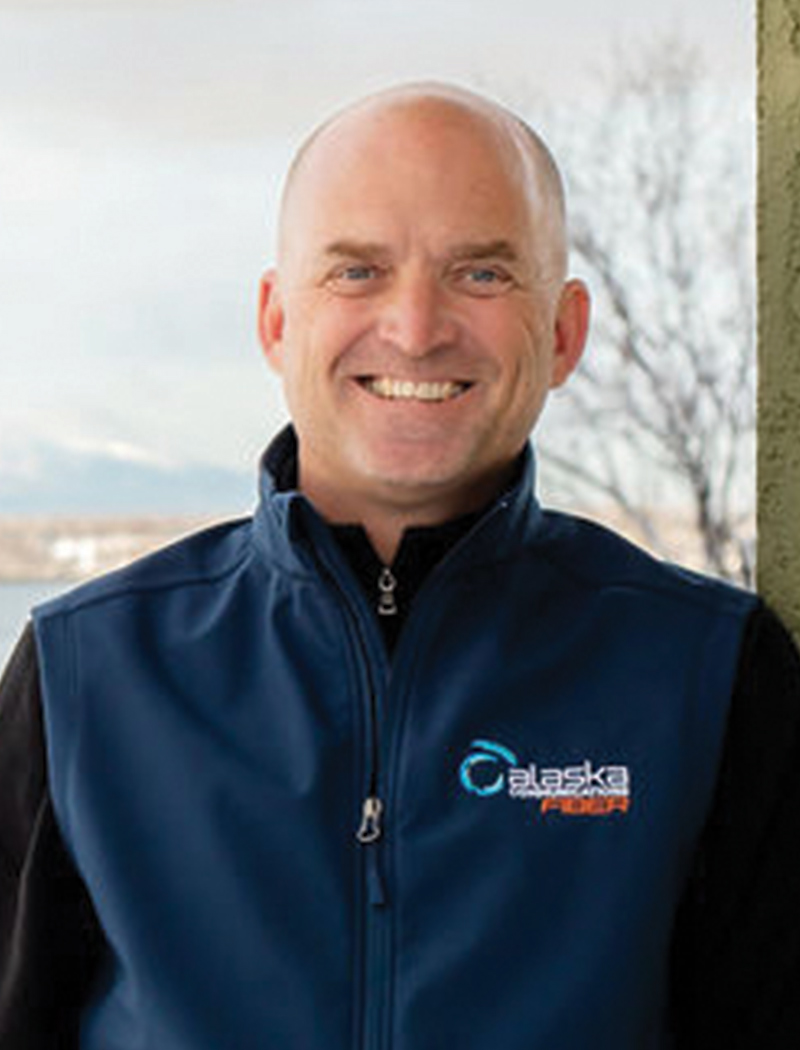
{"left": 36, "top": 436, "right": 753, "bottom": 1050}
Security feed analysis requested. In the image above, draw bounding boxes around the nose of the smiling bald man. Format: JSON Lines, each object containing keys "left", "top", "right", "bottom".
{"left": 378, "top": 274, "right": 457, "bottom": 357}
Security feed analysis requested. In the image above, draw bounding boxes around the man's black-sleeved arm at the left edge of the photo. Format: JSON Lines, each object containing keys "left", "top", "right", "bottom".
{"left": 0, "top": 626, "right": 102, "bottom": 1050}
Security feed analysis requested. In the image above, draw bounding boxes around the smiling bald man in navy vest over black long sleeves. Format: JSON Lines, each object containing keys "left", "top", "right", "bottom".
{"left": 0, "top": 85, "right": 800, "bottom": 1050}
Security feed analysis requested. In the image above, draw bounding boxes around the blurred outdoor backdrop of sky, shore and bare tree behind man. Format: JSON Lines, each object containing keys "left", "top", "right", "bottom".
{"left": 0, "top": 0, "right": 755, "bottom": 662}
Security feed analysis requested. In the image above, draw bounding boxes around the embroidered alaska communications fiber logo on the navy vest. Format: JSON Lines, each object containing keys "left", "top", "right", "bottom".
{"left": 459, "top": 740, "right": 631, "bottom": 817}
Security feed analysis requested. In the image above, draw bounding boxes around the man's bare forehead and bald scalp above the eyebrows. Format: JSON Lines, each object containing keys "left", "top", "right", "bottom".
{"left": 281, "top": 99, "right": 539, "bottom": 260}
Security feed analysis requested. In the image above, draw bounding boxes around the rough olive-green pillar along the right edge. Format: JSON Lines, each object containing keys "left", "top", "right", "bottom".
{"left": 758, "top": 0, "right": 800, "bottom": 638}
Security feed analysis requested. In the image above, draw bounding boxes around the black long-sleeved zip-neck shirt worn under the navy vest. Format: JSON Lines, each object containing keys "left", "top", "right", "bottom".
{"left": 0, "top": 529, "right": 800, "bottom": 1050}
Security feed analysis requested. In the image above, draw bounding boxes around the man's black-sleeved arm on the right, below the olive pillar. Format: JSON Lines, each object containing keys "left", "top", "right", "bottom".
{"left": 672, "top": 606, "right": 800, "bottom": 1050}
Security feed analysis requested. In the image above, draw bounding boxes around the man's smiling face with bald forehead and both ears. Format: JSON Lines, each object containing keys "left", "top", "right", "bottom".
{"left": 260, "top": 97, "right": 585, "bottom": 518}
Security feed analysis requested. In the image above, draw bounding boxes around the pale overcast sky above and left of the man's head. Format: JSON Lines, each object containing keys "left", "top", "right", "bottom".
{"left": 0, "top": 0, "right": 755, "bottom": 512}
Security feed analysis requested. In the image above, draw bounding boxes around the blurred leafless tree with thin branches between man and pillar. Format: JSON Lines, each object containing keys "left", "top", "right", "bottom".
{"left": 527, "top": 40, "right": 755, "bottom": 585}
